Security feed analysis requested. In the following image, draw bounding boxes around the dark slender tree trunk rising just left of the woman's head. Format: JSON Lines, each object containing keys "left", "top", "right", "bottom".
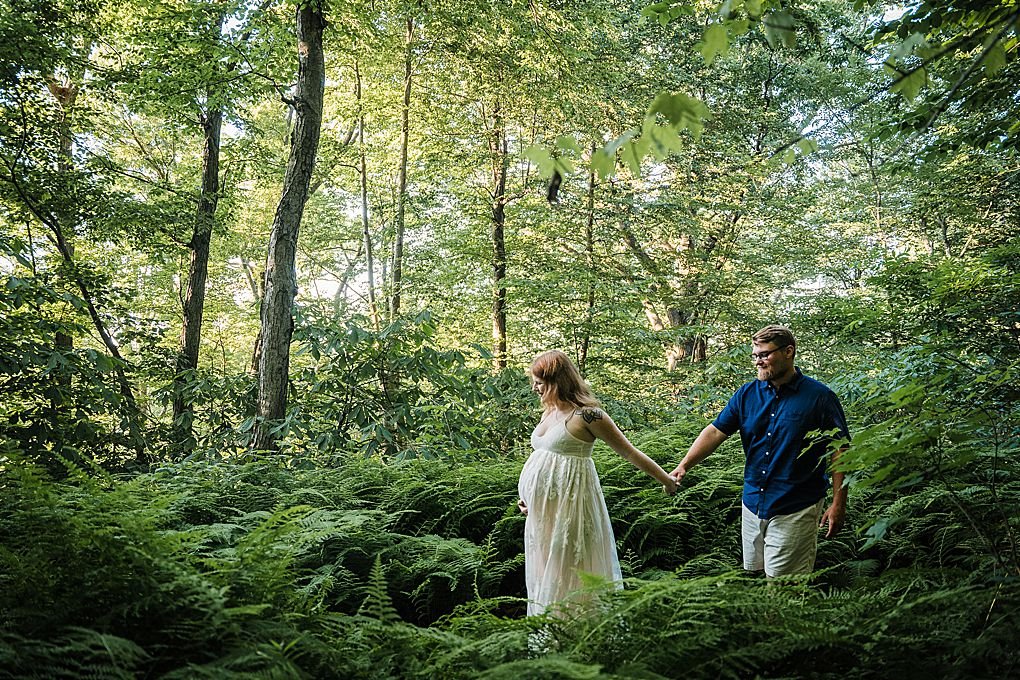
{"left": 490, "top": 100, "right": 510, "bottom": 370}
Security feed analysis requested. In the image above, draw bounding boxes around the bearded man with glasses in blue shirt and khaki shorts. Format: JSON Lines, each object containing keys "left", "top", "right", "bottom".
{"left": 670, "top": 325, "right": 850, "bottom": 577}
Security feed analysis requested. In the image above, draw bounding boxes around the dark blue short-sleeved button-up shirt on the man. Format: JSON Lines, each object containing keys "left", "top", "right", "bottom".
{"left": 712, "top": 368, "right": 850, "bottom": 519}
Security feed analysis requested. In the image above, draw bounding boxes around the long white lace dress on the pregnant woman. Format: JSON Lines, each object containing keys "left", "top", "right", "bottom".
{"left": 517, "top": 421, "right": 623, "bottom": 616}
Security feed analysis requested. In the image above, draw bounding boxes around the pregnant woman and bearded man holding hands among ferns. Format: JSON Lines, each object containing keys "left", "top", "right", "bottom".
{"left": 518, "top": 325, "right": 850, "bottom": 616}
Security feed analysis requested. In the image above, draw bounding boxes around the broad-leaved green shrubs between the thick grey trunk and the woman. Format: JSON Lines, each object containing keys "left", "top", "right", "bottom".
{"left": 282, "top": 310, "right": 532, "bottom": 458}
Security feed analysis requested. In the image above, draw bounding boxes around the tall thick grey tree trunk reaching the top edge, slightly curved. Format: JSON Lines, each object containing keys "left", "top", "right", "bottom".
{"left": 252, "top": 0, "right": 325, "bottom": 451}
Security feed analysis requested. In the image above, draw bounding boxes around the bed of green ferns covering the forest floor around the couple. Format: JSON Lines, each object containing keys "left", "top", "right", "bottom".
{"left": 0, "top": 417, "right": 1020, "bottom": 678}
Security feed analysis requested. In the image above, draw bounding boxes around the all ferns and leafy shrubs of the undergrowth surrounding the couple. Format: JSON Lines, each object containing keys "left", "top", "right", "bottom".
{"left": 0, "top": 251, "right": 1020, "bottom": 680}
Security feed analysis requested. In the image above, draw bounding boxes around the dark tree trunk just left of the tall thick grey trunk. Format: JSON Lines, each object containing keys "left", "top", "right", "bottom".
{"left": 173, "top": 97, "right": 223, "bottom": 441}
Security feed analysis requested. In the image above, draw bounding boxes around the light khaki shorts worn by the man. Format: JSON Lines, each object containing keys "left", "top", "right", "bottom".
{"left": 741, "top": 499, "right": 825, "bottom": 576}
